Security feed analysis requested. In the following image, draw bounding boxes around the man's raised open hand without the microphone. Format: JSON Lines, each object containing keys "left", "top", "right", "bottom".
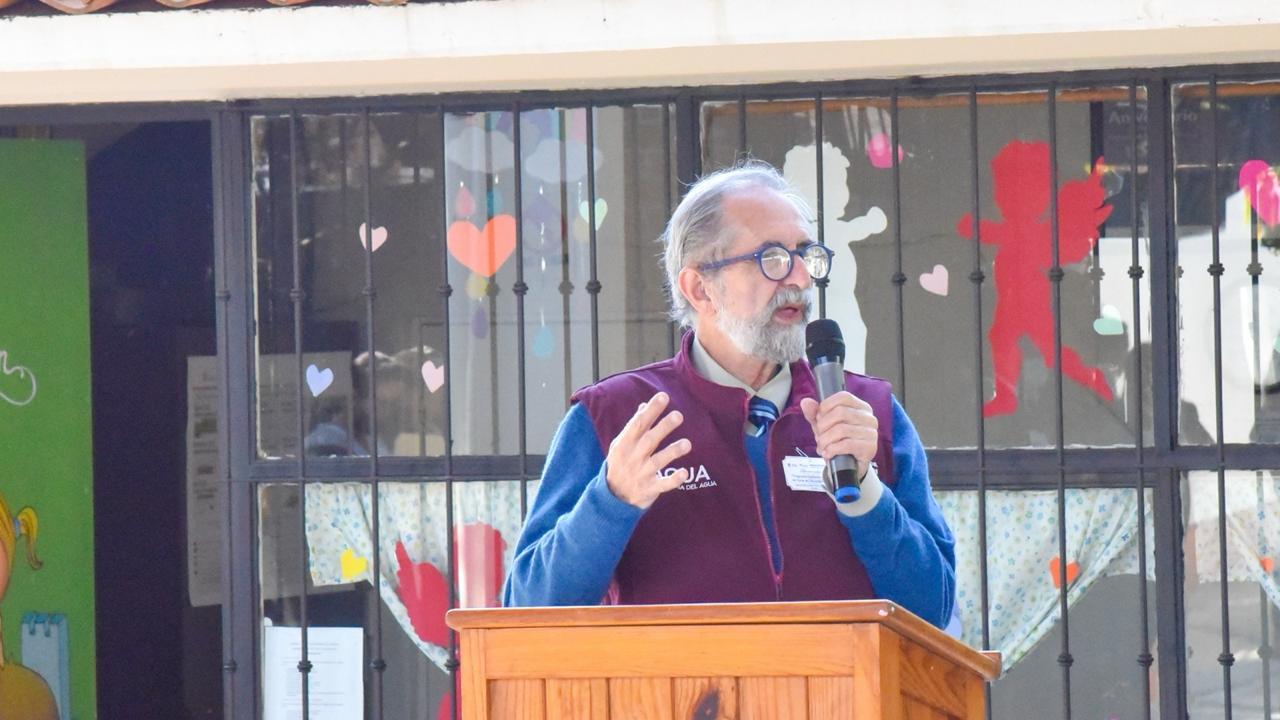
{"left": 604, "top": 392, "right": 692, "bottom": 510}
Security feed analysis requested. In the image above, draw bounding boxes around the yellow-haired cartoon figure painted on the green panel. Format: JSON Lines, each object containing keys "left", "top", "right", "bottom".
{"left": 0, "top": 495, "right": 58, "bottom": 720}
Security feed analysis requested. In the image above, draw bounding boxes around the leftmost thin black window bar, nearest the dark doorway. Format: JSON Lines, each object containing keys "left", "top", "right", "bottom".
{"left": 288, "top": 110, "right": 311, "bottom": 720}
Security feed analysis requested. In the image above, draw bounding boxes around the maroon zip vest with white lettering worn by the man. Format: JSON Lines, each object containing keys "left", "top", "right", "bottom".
{"left": 572, "top": 333, "right": 893, "bottom": 605}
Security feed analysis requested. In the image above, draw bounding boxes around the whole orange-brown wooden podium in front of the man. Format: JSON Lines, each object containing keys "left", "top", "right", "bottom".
{"left": 448, "top": 600, "right": 1000, "bottom": 720}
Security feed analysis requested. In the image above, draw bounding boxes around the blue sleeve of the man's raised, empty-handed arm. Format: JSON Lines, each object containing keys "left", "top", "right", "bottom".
{"left": 502, "top": 405, "right": 644, "bottom": 607}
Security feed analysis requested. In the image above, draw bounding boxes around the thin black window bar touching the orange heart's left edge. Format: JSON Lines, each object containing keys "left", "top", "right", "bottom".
{"left": 436, "top": 105, "right": 458, "bottom": 719}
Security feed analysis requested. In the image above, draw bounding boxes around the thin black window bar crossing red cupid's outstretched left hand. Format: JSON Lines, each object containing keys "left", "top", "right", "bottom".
{"left": 969, "top": 86, "right": 992, "bottom": 720}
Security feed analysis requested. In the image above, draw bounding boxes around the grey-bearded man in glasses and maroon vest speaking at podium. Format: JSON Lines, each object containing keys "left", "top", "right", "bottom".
{"left": 503, "top": 161, "right": 955, "bottom": 626}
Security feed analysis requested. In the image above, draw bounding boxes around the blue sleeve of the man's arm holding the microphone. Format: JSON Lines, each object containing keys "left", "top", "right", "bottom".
{"left": 840, "top": 398, "right": 956, "bottom": 628}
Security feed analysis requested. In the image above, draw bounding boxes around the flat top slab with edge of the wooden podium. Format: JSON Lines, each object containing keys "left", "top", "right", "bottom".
{"left": 445, "top": 600, "right": 1001, "bottom": 680}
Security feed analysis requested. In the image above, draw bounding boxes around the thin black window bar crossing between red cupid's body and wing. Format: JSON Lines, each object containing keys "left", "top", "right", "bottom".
{"left": 1048, "top": 83, "right": 1073, "bottom": 720}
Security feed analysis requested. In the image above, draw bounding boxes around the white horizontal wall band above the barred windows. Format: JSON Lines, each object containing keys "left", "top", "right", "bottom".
{"left": 0, "top": 0, "right": 1280, "bottom": 105}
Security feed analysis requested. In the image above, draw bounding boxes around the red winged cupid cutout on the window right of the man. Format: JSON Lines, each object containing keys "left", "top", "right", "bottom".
{"left": 956, "top": 140, "right": 1112, "bottom": 418}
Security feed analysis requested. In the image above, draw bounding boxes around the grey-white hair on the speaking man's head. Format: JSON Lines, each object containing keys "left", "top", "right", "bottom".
{"left": 662, "top": 160, "right": 812, "bottom": 328}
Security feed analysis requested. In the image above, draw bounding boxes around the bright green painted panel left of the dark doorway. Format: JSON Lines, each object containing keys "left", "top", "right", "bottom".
{"left": 0, "top": 140, "right": 97, "bottom": 720}
